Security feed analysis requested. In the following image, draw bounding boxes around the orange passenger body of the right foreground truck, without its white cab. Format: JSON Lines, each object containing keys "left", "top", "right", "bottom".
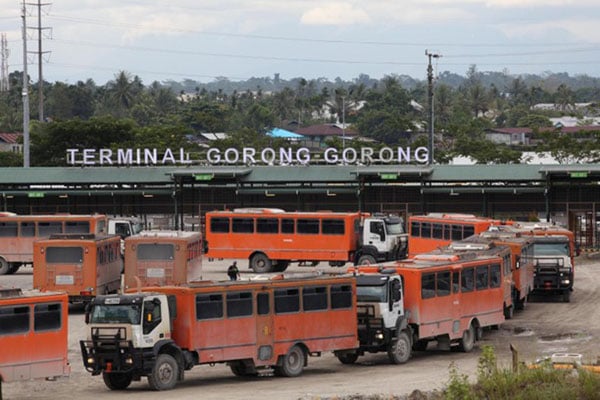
{"left": 349, "top": 253, "right": 506, "bottom": 352}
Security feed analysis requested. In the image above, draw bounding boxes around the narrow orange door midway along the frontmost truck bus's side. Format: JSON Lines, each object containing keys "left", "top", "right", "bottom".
{"left": 256, "top": 291, "right": 275, "bottom": 365}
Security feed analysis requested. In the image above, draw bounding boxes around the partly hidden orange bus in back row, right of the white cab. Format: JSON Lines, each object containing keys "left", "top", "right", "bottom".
{"left": 408, "top": 213, "right": 510, "bottom": 257}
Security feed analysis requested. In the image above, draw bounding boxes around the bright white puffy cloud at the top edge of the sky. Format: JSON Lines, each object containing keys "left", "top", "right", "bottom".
{"left": 300, "top": 2, "right": 371, "bottom": 25}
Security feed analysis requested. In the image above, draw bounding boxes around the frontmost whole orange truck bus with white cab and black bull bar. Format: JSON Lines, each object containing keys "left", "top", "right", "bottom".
{"left": 80, "top": 275, "right": 358, "bottom": 390}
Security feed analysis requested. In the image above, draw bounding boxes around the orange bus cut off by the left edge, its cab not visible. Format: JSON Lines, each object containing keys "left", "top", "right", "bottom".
{"left": 0, "top": 289, "right": 71, "bottom": 393}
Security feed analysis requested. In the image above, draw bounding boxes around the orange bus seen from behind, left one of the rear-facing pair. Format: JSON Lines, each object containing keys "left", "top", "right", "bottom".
{"left": 33, "top": 233, "right": 123, "bottom": 303}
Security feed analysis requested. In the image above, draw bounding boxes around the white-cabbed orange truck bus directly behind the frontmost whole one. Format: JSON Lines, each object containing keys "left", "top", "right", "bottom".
{"left": 344, "top": 254, "right": 505, "bottom": 364}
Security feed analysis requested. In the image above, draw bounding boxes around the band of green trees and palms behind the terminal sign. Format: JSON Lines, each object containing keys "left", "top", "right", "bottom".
{"left": 0, "top": 66, "right": 600, "bottom": 166}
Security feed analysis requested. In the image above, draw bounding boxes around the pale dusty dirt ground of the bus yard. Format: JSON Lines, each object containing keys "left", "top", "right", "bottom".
{"left": 0, "top": 256, "right": 600, "bottom": 400}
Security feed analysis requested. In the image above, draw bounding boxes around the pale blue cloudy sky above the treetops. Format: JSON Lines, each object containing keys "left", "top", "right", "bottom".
{"left": 0, "top": 0, "right": 600, "bottom": 84}
